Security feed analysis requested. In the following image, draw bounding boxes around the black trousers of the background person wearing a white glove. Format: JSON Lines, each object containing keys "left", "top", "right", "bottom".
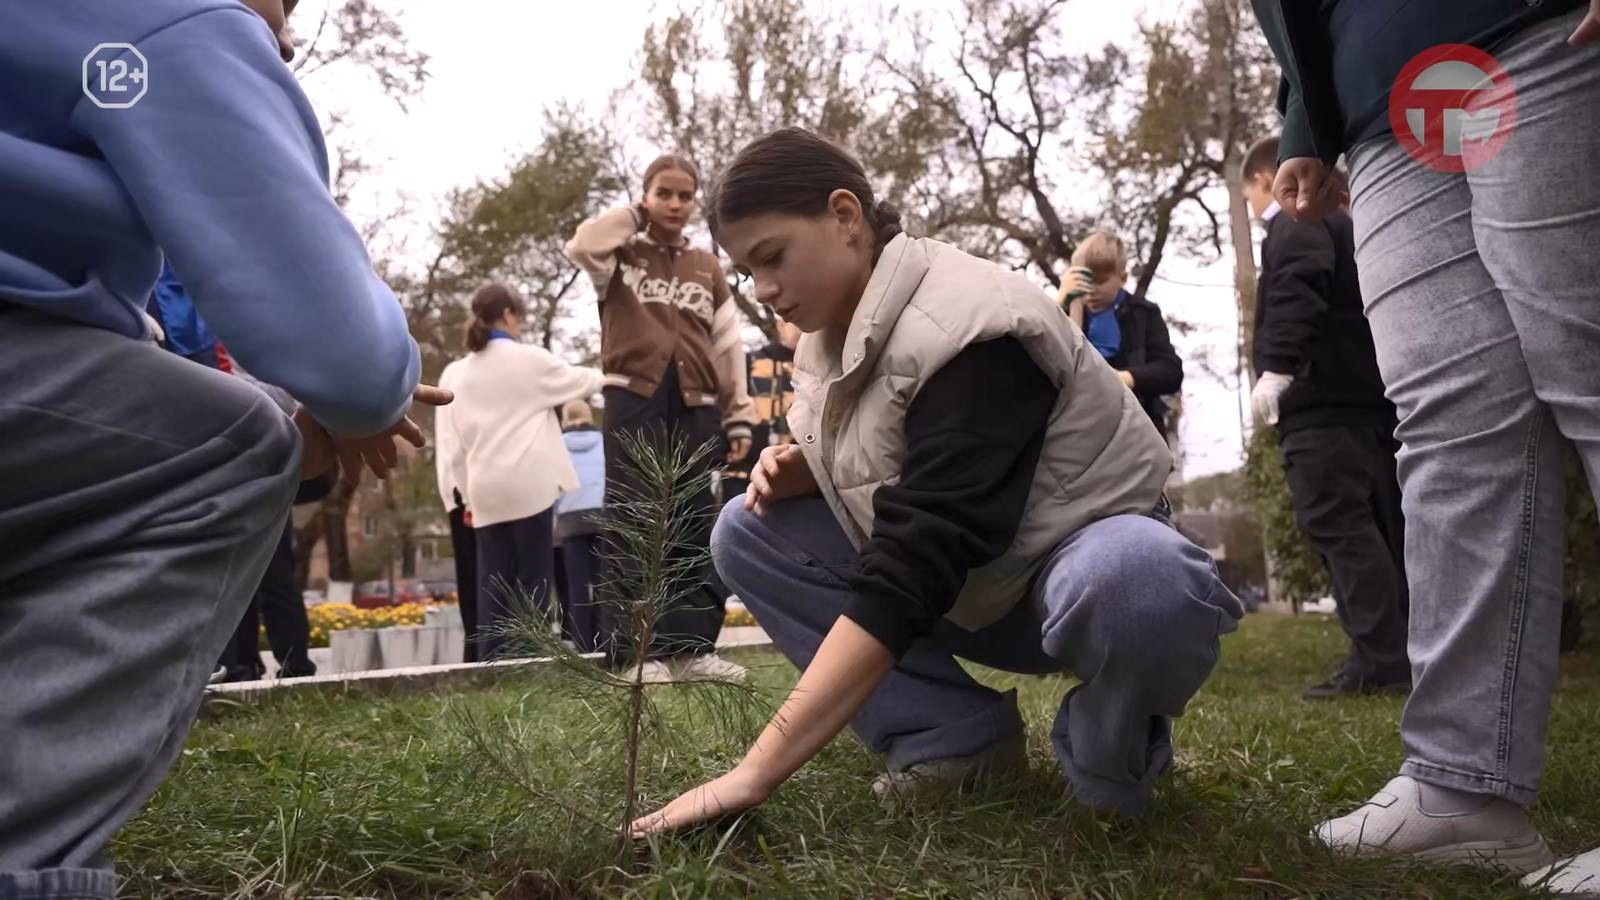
{"left": 1282, "top": 426, "right": 1411, "bottom": 682}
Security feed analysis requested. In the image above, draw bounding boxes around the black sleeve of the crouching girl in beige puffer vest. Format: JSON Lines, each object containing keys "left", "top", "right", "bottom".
{"left": 845, "top": 338, "right": 1056, "bottom": 658}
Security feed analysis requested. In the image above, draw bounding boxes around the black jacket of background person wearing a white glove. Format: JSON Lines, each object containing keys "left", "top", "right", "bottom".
{"left": 1251, "top": 211, "right": 1395, "bottom": 437}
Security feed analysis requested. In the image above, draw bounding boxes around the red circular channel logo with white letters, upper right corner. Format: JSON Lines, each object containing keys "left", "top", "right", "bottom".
{"left": 1389, "top": 43, "right": 1517, "bottom": 171}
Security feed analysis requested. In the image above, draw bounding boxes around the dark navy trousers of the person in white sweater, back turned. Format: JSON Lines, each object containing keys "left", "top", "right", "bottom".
{"left": 474, "top": 508, "right": 555, "bottom": 660}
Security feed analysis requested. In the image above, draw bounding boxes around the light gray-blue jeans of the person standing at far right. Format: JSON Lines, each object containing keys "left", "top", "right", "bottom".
{"left": 1350, "top": 10, "right": 1600, "bottom": 806}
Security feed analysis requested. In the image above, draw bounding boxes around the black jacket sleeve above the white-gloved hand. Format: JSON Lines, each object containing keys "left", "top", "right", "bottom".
{"left": 1254, "top": 213, "right": 1336, "bottom": 375}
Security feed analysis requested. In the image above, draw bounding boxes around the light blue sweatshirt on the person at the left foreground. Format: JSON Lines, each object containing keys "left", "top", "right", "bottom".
{"left": 0, "top": 0, "right": 421, "bottom": 436}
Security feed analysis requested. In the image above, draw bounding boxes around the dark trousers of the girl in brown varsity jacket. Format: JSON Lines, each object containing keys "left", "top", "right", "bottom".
{"left": 600, "top": 365, "right": 728, "bottom": 658}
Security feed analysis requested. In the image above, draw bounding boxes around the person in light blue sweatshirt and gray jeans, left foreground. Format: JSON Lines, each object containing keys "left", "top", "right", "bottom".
{"left": 0, "top": 0, "right": 448, "bottom": 900}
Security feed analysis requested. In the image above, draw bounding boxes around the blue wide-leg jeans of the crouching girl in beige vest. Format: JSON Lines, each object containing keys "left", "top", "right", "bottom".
{"left": 712, "top": 498, "right": 1243, "bottom": 814}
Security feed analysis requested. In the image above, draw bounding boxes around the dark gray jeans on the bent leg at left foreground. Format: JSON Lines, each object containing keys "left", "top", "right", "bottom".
{"left": 0, "top": 304, "right": 299, "bottom": 900}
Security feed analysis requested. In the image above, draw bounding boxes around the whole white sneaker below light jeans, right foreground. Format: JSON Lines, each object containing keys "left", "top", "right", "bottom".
{"left": 1310, "top": 775, "right": 1555, "bottom": 873}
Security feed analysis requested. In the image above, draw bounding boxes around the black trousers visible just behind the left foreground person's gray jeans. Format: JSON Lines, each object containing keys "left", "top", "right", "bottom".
{"left": 222, "top": 520, "right": 317, "bottom": 681}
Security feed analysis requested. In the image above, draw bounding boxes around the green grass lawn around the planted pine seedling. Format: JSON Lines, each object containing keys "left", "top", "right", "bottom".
{"left": 114, "top": 615, "right": 1600, "bottom": 900}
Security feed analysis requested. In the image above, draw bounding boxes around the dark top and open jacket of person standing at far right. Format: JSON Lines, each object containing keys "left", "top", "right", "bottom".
{"left": 1251, "top": 0, "right": 1584, "bottom": 162}
